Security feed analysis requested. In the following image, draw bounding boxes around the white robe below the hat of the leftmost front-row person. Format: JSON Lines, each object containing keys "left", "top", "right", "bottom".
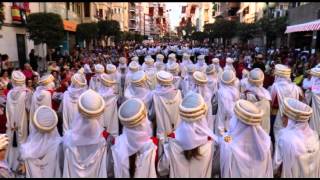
{"left": 21, "top": 128, "right": 63, "bottom": 178}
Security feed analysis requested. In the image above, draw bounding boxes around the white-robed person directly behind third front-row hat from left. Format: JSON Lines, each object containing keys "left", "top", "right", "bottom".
{"left": 124, "top": 71, "right": 153, "bottom": 119}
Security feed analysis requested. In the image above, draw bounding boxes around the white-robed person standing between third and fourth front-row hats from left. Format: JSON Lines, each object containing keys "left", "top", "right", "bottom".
{"left": 153, "top": 71, "right": 182, "bottom": 158}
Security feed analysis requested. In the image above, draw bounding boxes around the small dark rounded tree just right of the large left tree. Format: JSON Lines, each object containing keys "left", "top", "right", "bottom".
{"left": 76, "top": 22, "right": 98, "bottom": 47}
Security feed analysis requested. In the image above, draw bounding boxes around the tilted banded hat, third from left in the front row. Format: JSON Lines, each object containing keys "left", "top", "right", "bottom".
{"left": 118, "top": 98, "right": 147, "bottom": 128}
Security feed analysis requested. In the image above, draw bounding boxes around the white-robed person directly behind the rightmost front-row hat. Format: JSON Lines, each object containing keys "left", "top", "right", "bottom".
{"left": 270, "top": 64, "right": 303, "bottom": 141}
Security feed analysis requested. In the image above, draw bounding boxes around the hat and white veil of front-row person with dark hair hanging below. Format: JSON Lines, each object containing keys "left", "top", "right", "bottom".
{"left": 176, "top": 93, "right": 217, "bottom": 150}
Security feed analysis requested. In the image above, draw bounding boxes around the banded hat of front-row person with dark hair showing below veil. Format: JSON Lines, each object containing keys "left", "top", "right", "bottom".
{"left": 179, "top": 92, "right": 207, "bottom": 122}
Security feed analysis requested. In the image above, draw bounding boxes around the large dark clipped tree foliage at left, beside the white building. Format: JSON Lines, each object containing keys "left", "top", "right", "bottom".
{"left": 26, "top": 12, "right": 64, "bottom": 48}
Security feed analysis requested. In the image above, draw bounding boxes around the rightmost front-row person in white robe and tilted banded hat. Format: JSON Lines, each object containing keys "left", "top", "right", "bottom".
{"left": 273, "top": 98, "right": 320, "bottom": 178}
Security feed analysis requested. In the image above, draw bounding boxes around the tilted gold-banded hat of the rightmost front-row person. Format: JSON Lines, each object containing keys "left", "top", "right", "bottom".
{"left": 282, "top": 98, "right": 313, "bottom": 122}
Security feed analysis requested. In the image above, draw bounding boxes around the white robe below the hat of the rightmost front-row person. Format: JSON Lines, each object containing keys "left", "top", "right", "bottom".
{"left": 274, "top": 119, "right": 320, "bottom": 178}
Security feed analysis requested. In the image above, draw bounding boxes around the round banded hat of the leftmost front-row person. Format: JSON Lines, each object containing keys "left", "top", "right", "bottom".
{"left": 33, "top": 106, "right": 58, "bottom": 132}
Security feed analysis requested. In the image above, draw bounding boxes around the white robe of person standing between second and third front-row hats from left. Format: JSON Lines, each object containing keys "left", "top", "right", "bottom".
{"left": 98, "top": 86, "right": 119, "bottom": 137}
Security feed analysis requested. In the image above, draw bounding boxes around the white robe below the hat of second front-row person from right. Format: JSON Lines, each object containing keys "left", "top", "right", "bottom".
{"left": 220, "top": 116, "right": 273, "bottom": 178}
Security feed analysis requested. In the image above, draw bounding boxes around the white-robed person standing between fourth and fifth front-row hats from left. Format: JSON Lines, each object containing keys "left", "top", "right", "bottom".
{"left": 214, "top": 70, "right": 240, "bottom": 133}
